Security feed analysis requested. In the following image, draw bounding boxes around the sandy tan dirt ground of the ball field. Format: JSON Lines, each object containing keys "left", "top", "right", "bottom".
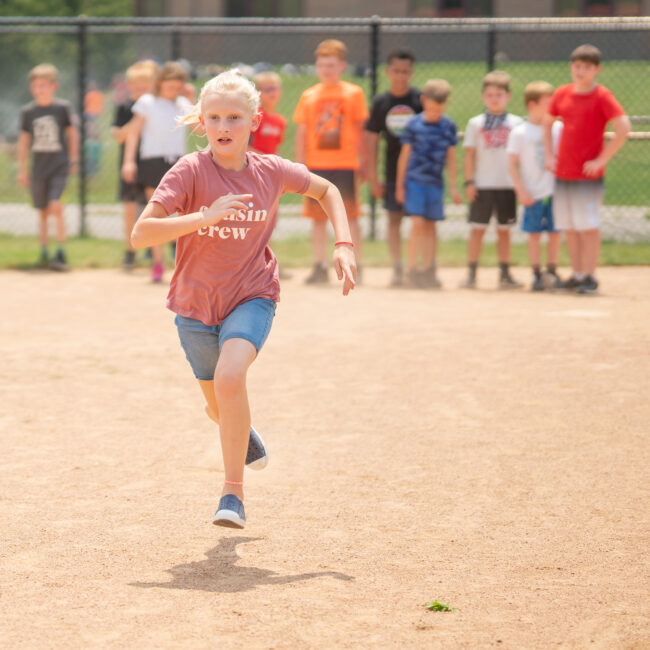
{"left": 0, "top": 268, "right": 650, "bottom": 649}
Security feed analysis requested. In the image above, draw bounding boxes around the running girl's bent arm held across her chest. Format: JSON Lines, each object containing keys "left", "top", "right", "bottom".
{"left": 131, "top": 194, "right": 253, "bottom": 248}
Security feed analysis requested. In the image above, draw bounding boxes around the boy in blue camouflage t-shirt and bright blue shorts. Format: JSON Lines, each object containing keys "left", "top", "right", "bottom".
{"left": 395, "top": 79, "right": 462, "bottom": 289}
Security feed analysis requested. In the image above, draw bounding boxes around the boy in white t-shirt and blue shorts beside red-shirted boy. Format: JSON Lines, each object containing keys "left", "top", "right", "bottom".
{"left": 507, "top": 81, "right": 562, "bottom": 291}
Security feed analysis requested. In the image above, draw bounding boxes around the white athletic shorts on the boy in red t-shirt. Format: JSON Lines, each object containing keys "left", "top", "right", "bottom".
{"left": 553, "top": 178, "right": 604, "bottom": 230}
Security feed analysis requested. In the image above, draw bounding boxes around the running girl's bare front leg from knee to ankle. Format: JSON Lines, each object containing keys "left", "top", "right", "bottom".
{"left": 214, "top": 339, "right": 257, "bottom": 500}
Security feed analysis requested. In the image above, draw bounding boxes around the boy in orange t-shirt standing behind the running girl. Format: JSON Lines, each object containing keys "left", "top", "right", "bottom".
{"left": 293, "top": 40, "right": 368, "bottom": 284}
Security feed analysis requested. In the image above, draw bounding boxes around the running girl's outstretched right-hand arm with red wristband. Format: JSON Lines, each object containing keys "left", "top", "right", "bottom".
{"left": 305, "top": 174, "right": 357, "bottom": 296}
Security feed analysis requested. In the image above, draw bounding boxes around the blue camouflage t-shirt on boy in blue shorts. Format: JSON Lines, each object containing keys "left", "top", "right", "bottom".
{"left": 402, "top": 113, "right": 458, "bottom": 187}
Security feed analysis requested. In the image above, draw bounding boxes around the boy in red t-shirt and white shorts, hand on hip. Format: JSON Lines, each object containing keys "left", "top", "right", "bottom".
{"left": 544, "top": 45, "right": 630, "bottom": 294}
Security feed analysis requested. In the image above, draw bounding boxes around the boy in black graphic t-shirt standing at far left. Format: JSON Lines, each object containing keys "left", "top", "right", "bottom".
{"left": 18, "top": 63, "right": 79, "bottom": 270}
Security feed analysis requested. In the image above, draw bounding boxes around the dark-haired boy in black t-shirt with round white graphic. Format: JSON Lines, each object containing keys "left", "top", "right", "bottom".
{"left": 366, "top": 49, "right": 422, "bottom": 286}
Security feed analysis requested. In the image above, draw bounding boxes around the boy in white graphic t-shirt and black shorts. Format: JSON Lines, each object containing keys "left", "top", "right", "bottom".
{"left": 460, "top": 70, "right": 523, "bottom": 289}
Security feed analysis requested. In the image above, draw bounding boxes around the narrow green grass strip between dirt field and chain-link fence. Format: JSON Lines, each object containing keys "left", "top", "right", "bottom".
{"left": 0, "top": 233, "right": 650, "bottom": 269}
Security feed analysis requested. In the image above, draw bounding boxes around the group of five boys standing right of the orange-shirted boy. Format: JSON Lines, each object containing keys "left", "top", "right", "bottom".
{"left": 366, "top": 45, "right": 630, "bottom": 293}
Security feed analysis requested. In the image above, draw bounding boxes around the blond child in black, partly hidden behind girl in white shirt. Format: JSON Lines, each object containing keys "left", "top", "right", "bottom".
{"left": 112, "top": 60, "right": 158, "bottom": 270}
